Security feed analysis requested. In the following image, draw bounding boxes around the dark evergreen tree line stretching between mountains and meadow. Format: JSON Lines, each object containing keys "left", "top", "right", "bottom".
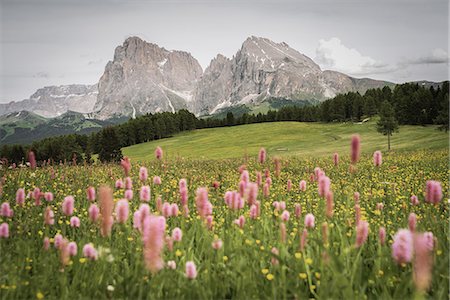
{"left": 0, "top": 81, "right": 449, "bottom": 164}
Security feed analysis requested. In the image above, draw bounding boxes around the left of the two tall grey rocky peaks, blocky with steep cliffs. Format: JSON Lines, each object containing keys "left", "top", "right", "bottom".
{"left": 93, "top": 37, "right": 203, "bottom": 120}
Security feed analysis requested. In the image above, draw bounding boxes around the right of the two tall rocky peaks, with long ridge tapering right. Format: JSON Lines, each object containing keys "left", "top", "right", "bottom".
{"left": 192, "top": 36, "right": 393, "bottom": 115}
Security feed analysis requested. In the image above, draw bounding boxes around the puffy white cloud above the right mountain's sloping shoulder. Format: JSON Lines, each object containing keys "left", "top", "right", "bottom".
{"left": 314, "top": 37, "right": 397, "bottom": 76}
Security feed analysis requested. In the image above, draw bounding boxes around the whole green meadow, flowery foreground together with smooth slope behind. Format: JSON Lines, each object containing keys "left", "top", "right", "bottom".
{"left": 0, "top": 123, "right": 450, "bottom": 299}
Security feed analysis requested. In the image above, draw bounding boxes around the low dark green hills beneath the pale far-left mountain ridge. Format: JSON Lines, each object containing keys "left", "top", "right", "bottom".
{"left": 0, "top": 111, "right": 114, "bottom": 144}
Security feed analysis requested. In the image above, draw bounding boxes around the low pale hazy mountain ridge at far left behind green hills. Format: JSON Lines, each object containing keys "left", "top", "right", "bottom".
{"left": 0, "top": 84, "right": 97, "bottom": 118}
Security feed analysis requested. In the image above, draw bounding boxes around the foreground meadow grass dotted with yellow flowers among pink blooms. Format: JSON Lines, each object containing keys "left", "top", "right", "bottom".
{"left": 0, "top": 149, "right": 450, "bottom": 300}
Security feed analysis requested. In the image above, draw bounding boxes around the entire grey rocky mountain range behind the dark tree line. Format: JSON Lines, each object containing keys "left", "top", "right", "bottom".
{"left": 0, "top": 36, "right": 442, "bottom": 143}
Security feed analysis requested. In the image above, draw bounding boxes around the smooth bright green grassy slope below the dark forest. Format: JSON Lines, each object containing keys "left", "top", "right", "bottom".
{"left": 123, "top": 121, "right": 448, "bottom": 161}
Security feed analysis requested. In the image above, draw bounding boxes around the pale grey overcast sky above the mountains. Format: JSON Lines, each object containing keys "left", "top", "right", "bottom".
{"left": 0, "top": 0, "right": 449, "bottom": 103}
